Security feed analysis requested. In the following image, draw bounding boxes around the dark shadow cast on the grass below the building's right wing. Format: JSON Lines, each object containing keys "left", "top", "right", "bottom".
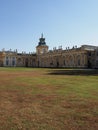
{"left": 48, "top": 69, "right": 98, "bottom": 76}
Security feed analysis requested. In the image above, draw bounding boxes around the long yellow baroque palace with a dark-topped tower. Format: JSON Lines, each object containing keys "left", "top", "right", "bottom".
{"left": 0, "top": 34, "right": 98, "bottom": 68}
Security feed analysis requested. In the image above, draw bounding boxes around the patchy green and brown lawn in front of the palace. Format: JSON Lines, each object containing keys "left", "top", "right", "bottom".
{"left": 0, "top": 68, "right": 98, "bottom": 130}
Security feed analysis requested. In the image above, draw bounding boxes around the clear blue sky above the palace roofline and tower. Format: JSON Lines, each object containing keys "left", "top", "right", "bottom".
{"left": 0, "top": 0, "right": 98, "bottom": 53}
